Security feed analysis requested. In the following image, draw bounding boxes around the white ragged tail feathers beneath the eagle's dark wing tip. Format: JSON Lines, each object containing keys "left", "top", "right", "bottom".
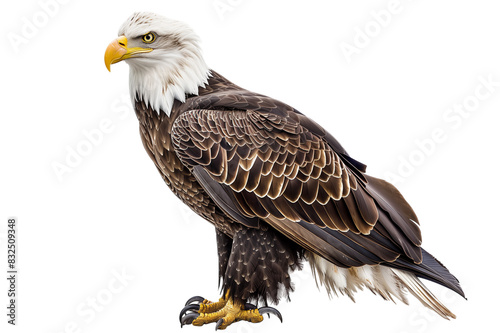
{"left": 306, "top": 252, "right": 455, "bottom": 319}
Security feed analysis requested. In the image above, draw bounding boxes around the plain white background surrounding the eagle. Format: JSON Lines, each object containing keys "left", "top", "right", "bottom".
{"left": 0, "top": 0, "right": 500, "bottom": 333}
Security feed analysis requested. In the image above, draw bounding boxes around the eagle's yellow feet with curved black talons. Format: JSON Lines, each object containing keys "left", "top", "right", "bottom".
{"left": 179, "top": 291, "right": 283, "bottom": 330}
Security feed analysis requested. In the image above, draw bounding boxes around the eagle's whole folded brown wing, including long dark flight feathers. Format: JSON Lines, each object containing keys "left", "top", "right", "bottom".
{"left": 171, "top": 104, "right": 422, "bottom": 267}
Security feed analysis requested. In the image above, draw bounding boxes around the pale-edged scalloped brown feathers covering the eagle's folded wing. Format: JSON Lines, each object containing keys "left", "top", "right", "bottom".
{"left": 172, "top": 110, "right": 378, "bottom": 235}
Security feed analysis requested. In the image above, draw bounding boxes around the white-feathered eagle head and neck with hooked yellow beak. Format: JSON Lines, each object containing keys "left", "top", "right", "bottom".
{"left": 104, "top": 12, "right": 210, "bottom": 115}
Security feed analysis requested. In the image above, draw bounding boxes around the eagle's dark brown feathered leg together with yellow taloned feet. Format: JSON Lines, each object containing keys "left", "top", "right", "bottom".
{"left": 179, "top": 225, "right": 303, "bottom": 329}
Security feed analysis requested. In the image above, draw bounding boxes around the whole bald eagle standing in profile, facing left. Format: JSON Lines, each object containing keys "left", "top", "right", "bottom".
{"left": 105, "top": 12, "right": 464, "bottom": 329}
